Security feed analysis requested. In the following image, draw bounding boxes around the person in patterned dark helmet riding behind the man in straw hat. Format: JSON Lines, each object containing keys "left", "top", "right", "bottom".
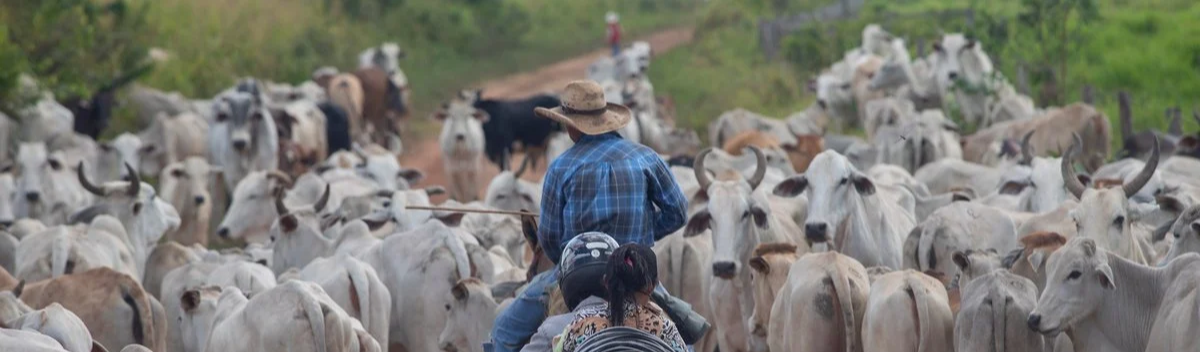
{"left": 521, "top": 232, "right": 618, "bottom": 352}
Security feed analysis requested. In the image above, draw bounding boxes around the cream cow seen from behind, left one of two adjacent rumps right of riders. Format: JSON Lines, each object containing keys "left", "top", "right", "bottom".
{"left": 767, "top": 252, "right": 871, "bottom": 352}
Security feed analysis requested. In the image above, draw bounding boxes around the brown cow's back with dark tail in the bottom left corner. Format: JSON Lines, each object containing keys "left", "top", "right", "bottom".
{"left": 20, "top": 268, "right": 167, "bottom": 351}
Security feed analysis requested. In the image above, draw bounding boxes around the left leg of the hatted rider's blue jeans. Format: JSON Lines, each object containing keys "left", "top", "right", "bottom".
{"left": 484, "top": 266, "right": 558, "bottom": 352}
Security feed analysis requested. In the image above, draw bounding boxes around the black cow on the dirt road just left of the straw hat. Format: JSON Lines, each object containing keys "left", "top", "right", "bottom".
{"left": 474, "top": 90, "right": 562, "bottom": 171}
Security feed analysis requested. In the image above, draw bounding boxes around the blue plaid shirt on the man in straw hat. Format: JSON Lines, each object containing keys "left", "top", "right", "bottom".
{"left": 538, "top": 132, "right": 688, "bottom": 263}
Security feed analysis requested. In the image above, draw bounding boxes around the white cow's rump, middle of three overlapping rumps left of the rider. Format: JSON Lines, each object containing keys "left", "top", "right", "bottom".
{"left": 288, "top": 253, "right": 391, "bottom": 342}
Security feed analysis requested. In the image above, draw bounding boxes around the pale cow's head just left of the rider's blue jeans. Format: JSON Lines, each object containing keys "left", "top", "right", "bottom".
{"left": 438, "top": 278, "right": 497, "bottom": 352}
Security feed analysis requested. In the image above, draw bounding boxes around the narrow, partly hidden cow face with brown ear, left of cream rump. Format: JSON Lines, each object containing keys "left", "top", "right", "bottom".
{"left": 750, "top": 243, "right": 799, "bottom": 338}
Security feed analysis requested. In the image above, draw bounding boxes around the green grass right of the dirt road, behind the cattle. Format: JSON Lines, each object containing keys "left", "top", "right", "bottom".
{"left": 650, "top": 0, "right": 1200, "bottom": 144}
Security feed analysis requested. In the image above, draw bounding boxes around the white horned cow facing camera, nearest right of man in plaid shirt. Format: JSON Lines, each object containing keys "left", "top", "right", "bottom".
{"left": 683, "top": 147, "right": 809, "bottom": 350}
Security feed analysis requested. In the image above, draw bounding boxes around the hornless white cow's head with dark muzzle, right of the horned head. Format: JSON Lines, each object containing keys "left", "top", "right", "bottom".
{"left": 774, "top": 150, "right": 875, "bottom": 243}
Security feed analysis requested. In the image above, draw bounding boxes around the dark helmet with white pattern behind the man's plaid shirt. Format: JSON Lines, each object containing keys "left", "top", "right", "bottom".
{"left": 558, "top": 232, "right": 619, "bottom": 310}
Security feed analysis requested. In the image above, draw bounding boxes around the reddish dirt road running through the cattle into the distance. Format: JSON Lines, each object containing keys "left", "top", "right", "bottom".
{"left": 400, "top": 28, "right": 692, "bottom": 203}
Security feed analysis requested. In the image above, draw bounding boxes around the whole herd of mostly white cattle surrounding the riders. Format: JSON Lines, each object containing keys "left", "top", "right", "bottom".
{"left": 0, "top": 25, "right": 1200, "bottom": 352}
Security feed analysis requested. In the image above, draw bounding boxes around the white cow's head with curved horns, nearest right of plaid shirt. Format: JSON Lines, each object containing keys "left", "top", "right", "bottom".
{"left": 684, "top": 147, "right": 770, "bottom": 280}
